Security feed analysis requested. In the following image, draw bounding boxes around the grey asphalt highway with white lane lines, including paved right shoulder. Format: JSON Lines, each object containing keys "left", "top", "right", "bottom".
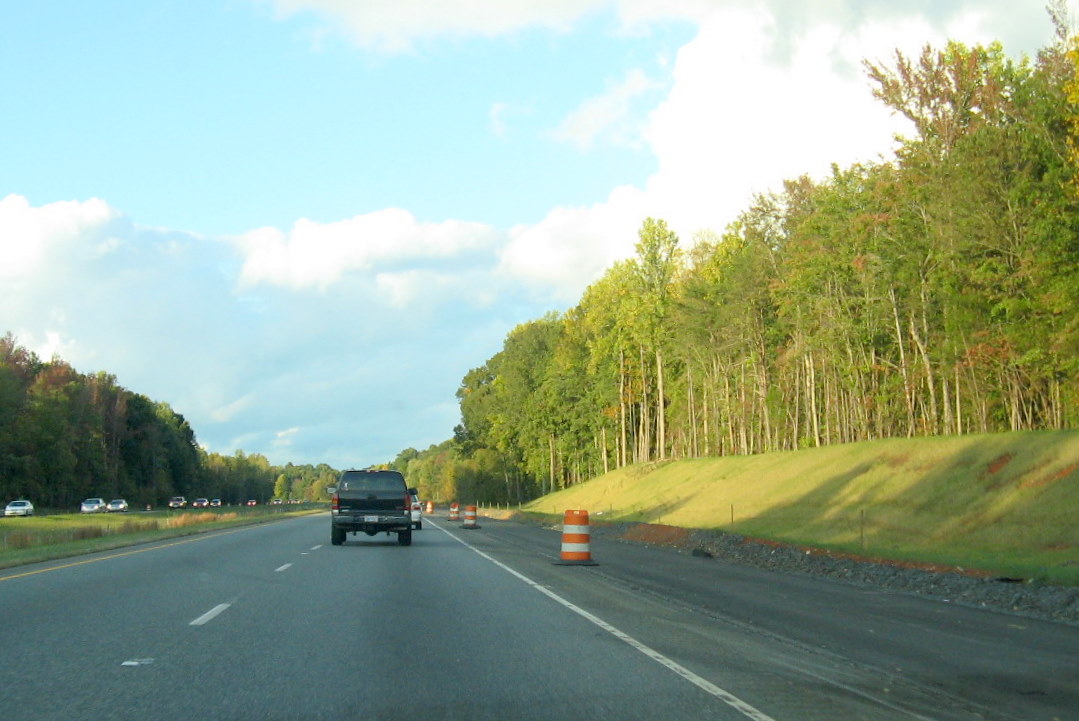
{"left": 0, "top": 515, "right": 1079, "bottom": 721}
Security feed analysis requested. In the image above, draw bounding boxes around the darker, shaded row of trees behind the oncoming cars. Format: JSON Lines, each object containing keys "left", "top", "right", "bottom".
{"left": 0, "top": 332, "right": 337, "bottom": 509}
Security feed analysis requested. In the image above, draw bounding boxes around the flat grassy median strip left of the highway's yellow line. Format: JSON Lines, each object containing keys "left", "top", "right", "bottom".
{"left": 0, "top": 506, "right": 323, "bottom": 569}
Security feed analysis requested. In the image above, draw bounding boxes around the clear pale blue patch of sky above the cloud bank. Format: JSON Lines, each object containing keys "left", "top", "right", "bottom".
{"left": 6, "top": 0, "right": 693, "bottom": 234}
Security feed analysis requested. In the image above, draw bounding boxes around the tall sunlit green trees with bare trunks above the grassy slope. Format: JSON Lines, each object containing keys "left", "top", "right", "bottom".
{"left": 405, "top": 21, "right": 1079, "bottom": 502}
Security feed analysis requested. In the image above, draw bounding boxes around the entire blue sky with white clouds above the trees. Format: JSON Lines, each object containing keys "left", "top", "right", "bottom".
{"left": 0, "top": 0, "right": 1077, "bottom": 468}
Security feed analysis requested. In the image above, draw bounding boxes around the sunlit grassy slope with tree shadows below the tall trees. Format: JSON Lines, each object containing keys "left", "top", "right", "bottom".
{"left": 523, "top": 431, "right": 1079, "bottom": 585}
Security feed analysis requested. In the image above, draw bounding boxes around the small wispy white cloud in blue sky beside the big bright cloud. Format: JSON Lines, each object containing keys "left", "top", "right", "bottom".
{"left": 552, "top": 68, "right": 661, "bottom": 150}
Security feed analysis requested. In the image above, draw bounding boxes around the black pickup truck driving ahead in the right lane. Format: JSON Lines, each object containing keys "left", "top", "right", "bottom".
{"left": 330, "top": 471, "right": 415, "bottom": 546}
